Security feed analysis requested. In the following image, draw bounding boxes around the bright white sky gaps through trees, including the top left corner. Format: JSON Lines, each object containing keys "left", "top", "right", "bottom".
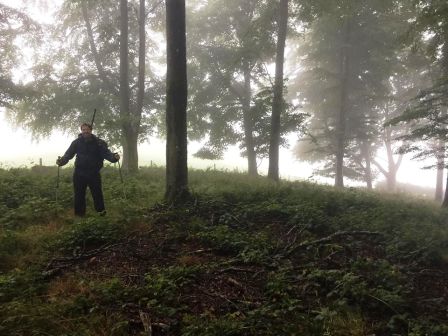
{"left": 0, "top": 0, "right": 435, "bottom": 187}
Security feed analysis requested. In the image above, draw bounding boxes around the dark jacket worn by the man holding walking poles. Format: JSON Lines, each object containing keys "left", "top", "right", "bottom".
{"left": 61, "top": 134, "right": 118, "bottom": 175}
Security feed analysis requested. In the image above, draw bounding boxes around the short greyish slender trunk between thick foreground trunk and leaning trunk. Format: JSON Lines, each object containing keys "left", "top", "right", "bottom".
{"left": 243, "top": 60, "right": 258, "bottom": 176}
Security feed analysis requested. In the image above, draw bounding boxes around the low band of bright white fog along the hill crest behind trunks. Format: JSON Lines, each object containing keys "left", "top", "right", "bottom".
{"left": 0, "top": 109, "right": 436, "bottom": 188}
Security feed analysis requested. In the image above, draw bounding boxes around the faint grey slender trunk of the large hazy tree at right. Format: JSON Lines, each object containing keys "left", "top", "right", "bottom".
{"left": 335, "top": 19, "right": 350, "bottom": 188}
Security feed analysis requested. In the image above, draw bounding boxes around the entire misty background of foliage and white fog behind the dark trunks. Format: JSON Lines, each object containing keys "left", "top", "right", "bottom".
{"left": 0, "top": 0, "right": 446, "bottom": 199}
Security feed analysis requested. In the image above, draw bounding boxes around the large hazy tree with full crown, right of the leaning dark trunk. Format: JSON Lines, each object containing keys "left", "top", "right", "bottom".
{"left": 294, "top": 0, "right": 403, "bottom": 187}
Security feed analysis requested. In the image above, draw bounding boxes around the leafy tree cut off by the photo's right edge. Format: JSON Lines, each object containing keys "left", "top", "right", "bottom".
{"left": 388, "top": 0, "right": 448, "bottom": 207}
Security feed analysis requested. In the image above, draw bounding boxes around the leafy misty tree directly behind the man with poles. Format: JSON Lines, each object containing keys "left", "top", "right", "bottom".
{"left": 7, "top": 0, "right": 163, "bottom": 171}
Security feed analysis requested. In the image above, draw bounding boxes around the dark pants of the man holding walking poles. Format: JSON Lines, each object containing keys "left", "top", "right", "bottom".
{"left": 73, "top": 172, "right": 105, "bottom": 216}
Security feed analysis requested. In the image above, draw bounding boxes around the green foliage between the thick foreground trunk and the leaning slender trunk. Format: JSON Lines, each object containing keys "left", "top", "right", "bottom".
{"left": 187, "top": 0, "right": 304, "bottom": 164}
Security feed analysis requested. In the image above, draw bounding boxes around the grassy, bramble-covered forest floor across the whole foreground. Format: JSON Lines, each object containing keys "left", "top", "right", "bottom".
{"left": 0, "top": 167, "right": 448, "bottom": 336}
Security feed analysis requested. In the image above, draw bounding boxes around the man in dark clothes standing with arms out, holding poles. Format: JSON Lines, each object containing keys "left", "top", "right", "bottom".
{"left": 56, "top": 123, "right": 120, "bottom": 217}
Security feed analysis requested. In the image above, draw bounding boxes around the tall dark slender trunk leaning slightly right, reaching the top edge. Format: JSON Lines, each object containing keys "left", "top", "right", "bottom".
{"left": 268, "top": 0, "right": 288, "bottom": 181}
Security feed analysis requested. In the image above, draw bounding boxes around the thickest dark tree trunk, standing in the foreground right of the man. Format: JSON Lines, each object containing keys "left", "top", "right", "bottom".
{"left": 165, "top": 0, "right": 189, "bottom": 204}
